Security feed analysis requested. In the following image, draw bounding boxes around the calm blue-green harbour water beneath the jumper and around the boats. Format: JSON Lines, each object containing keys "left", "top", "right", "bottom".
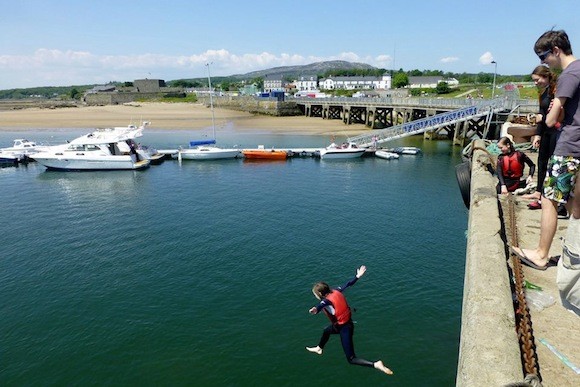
{"left": 0, "top": 130, "right": 467, "bottom": 386}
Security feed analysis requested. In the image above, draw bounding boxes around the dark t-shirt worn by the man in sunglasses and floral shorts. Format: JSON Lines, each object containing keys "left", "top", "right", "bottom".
{"left": 554, "top": 60, "right": 580, "bottom": 157}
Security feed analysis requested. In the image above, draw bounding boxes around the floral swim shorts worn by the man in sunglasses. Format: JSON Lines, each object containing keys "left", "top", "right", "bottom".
{"left": 544, "top": 156, "right": 580, "bottom": 203}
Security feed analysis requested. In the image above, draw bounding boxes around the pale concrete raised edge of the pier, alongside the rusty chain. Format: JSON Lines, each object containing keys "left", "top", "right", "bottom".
{"left": 456, "top": 140, "right": 523, "bottom": 387}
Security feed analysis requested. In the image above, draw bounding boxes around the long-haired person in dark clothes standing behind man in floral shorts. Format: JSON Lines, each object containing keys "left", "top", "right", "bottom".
{"left": 523, "top": 65, "right": 560, "bottom": 210}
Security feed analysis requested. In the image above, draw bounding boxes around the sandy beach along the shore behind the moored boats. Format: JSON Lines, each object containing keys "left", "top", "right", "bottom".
{"left": 0, "top": 102, "right": 369, "bottom": 137}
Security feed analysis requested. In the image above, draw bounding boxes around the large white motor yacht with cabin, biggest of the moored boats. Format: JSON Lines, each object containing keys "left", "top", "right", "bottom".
{"left": 31, "top": 125, "right": 151, "bottom": 171}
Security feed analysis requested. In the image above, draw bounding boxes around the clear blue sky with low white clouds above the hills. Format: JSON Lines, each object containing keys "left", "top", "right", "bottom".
{"left": 0, "top": 0, "right": 580, "bottom": 90}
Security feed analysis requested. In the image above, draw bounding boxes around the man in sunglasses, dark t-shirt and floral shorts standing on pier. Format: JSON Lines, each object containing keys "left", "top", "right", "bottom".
{"left": 511, "top": 30, "right": 580, "bottom": 278}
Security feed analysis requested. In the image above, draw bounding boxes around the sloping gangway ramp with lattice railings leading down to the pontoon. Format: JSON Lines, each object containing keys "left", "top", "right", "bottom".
{"left": 349, "top": 101, "right": 505, "bottom": 147}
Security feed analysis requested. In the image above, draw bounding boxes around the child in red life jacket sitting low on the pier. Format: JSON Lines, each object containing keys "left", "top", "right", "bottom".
{"left": 497, "top": 137, "right": 536, "bottom": 194}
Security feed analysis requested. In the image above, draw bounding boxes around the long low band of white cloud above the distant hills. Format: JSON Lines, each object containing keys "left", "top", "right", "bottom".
{"left": 0, "top": 48, "right": 392, "bottom": 89}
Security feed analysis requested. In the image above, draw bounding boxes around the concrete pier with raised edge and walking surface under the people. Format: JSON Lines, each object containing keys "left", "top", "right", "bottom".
{"left": 456, "top": 141, "right": 580, "bottom": 386}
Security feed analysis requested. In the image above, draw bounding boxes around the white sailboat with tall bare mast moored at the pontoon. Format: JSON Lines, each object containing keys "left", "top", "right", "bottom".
{"left": 177, "top": 63, "right": 240, "bottom": 161}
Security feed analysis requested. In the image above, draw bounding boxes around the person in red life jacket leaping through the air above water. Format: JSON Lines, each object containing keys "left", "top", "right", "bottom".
{"left": 306, "top": 265, "right": 393, "bottom": 375}
